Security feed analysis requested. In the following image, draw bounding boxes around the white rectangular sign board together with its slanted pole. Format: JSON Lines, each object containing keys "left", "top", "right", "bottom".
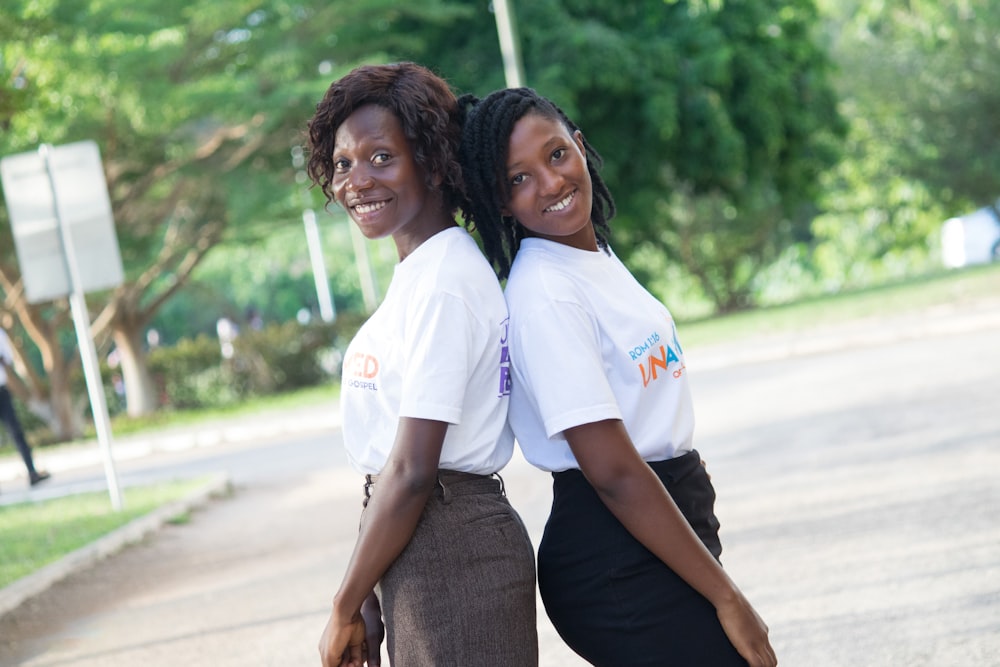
{"left": 0, "top": 141, "right": 123, "bottom": 511}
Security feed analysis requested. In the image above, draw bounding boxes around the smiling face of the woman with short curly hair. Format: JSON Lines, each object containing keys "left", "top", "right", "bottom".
{"left": 331, "top": 105, "right": 454, "bottom": 259}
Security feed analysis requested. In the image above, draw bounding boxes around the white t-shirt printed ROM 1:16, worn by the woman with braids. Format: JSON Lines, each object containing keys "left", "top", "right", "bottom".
{"left": 506, "top": 238, "right": 694, "bottom": 471}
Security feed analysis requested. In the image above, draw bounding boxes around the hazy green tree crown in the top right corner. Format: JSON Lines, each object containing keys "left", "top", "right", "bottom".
{"left": 841, "top": 0, "right": 1000, "bottom": 214}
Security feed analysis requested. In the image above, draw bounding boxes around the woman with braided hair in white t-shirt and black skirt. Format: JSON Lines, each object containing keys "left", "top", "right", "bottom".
{"left": 460, "top": 88, "right": 777, "bottom": 667}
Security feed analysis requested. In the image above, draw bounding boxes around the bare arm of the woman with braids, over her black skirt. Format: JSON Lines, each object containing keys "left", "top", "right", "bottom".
{"left": 564, "top": 419, "right": 777, "bottom": 667}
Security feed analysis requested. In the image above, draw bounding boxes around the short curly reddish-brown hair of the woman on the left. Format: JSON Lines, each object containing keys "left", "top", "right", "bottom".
{"left": 306, "top": 62, "right": 466, "bottom": 214}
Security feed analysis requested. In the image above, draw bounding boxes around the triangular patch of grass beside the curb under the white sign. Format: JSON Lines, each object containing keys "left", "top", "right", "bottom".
{"left": 0, "top": 477, "right": 208, "bottom": 588}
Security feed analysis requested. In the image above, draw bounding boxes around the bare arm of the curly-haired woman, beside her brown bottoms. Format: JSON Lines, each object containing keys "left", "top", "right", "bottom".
{"left": 319, "top": 417, "right": 448, "bottom": 667}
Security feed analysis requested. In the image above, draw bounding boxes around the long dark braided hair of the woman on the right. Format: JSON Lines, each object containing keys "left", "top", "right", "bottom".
{"left": 458, "top": 88, "right": 615, "bottom": 280}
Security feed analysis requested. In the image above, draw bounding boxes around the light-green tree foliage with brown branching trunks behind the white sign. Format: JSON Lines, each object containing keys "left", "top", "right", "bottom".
{"left": 0, "top": 0, "right": 416, "bottom": 422}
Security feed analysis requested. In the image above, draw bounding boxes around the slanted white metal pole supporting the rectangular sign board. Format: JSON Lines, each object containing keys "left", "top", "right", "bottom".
{"left": 38, "top": 144, "right": 123, "bottom": 512}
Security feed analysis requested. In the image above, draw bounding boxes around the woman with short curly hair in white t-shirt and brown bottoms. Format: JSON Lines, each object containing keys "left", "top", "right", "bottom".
{"left": 308, "top": 63, "right": 538, "bottom": 667}
